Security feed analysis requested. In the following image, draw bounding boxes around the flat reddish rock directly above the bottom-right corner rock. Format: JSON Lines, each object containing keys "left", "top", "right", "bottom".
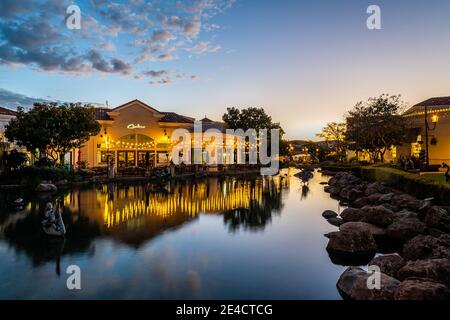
{"left": 397, "top": 259, "right": 450, "bottom": 286}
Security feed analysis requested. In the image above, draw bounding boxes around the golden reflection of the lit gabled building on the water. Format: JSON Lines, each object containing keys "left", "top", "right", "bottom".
{"left": 64, "top": 178, "right": 282, "bottom": 245}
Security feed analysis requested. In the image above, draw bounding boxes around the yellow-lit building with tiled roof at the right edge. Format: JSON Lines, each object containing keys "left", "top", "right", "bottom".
{"left": 397, "top": 97, "right": 450, "bottom": 165}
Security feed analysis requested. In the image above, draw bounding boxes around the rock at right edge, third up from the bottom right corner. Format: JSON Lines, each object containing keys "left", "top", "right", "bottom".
{"left": 403, "top": 235, "right": 450, "bottom": 260}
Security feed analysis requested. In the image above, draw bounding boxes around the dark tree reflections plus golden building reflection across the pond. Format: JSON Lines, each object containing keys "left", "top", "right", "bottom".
{"left": 0, "top": 178, "right": 286, "bottom": 255}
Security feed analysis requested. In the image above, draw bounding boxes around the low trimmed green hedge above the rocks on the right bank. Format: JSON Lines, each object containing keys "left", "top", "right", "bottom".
{"left": 355, "top": 166, "right": 450, "bottom": 205}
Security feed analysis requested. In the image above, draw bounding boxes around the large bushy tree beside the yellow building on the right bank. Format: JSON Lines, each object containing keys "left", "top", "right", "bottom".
{"left": 345, "top": 94, "right": 408, "bottom": 162}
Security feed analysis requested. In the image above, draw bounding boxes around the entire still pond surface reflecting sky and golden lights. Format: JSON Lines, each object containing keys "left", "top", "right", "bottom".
{"left": 0, "top": 171, "right": 344, "bottom": 299}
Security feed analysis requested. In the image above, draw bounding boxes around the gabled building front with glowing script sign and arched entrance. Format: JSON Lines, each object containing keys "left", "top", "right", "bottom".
{"left": 74, "top": 100, "right": 232, "bottom": 169}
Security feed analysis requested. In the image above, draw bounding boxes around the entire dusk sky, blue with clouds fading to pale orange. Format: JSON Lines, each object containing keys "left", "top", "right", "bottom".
{"left": 0, "top": 0, "right": 450, "bottom": 139}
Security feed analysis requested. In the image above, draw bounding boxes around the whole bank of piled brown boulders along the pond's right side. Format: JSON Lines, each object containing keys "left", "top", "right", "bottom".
{"left": 323, "top": 172, "right": 450, "bottom": 300}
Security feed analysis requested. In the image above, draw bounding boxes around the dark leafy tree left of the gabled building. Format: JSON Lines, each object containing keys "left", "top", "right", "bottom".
{"left": 5, "top": 103, "right": 101, "bottom": 161}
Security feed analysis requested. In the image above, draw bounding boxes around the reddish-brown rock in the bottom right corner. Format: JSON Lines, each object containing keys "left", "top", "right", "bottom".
{"left": 394, "top": 279, "right": 450, "bottom": 300}
